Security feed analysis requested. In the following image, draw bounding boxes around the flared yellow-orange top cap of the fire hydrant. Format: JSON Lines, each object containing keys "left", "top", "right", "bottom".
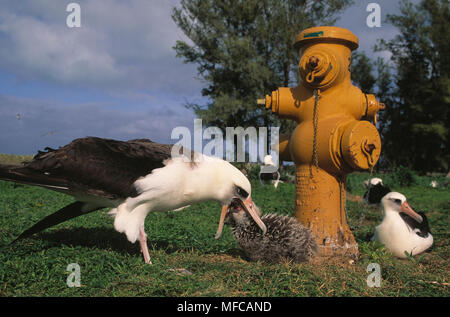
{"left": 294, "top": 26, "right": 359, "bottom": 51}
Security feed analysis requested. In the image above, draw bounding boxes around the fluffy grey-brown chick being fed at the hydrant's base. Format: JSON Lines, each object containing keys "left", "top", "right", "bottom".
{"left": 226, "top": 199, "right": 317, "bottom": 263}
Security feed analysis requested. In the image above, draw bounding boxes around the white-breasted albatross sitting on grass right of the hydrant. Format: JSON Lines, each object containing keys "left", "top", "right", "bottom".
{"left": 372, "top": 192, "right": 433, "bottom": 258}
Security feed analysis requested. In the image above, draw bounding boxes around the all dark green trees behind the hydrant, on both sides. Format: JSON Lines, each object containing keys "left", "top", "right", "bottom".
{"left": 172, "top": 0, "right": 450, "bottom": 172}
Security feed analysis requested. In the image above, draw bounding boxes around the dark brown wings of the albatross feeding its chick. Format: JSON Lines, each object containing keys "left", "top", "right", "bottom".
{"left": 0, "top": 137, "right": 172, "bottom": 241}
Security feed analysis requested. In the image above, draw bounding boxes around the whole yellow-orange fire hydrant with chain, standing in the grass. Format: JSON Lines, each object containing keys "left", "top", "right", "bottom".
{"left": 258, "top": 26, "right": 384, "bottom": 256}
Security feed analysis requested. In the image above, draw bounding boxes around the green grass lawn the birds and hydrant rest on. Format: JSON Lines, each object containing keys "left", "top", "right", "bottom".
{"left": 0, "top": 167, "right": 450, "bottom": 297}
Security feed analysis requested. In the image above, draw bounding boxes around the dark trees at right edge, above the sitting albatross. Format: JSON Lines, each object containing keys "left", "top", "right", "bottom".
{"left": 376, "top": 0, "right": 450, "bottom": 172}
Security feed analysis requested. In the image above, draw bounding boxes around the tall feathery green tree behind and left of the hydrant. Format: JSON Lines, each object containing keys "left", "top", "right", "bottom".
{"left": 172, "top": 0, "right": 352, "bottom": 131}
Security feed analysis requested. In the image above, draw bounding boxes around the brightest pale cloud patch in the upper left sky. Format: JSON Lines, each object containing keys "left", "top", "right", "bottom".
{"left": 0, "top": 13, "right": 120, "bottom": 84}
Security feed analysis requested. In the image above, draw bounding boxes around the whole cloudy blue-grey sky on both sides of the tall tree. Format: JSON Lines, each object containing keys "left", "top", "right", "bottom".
{"left": 0, "top": 0, "right": 417, "bottom": 154}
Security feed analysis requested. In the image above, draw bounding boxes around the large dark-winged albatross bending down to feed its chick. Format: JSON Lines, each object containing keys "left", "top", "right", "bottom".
{"left": 0, "top": 137, "right": 266, "bottom": 263}
